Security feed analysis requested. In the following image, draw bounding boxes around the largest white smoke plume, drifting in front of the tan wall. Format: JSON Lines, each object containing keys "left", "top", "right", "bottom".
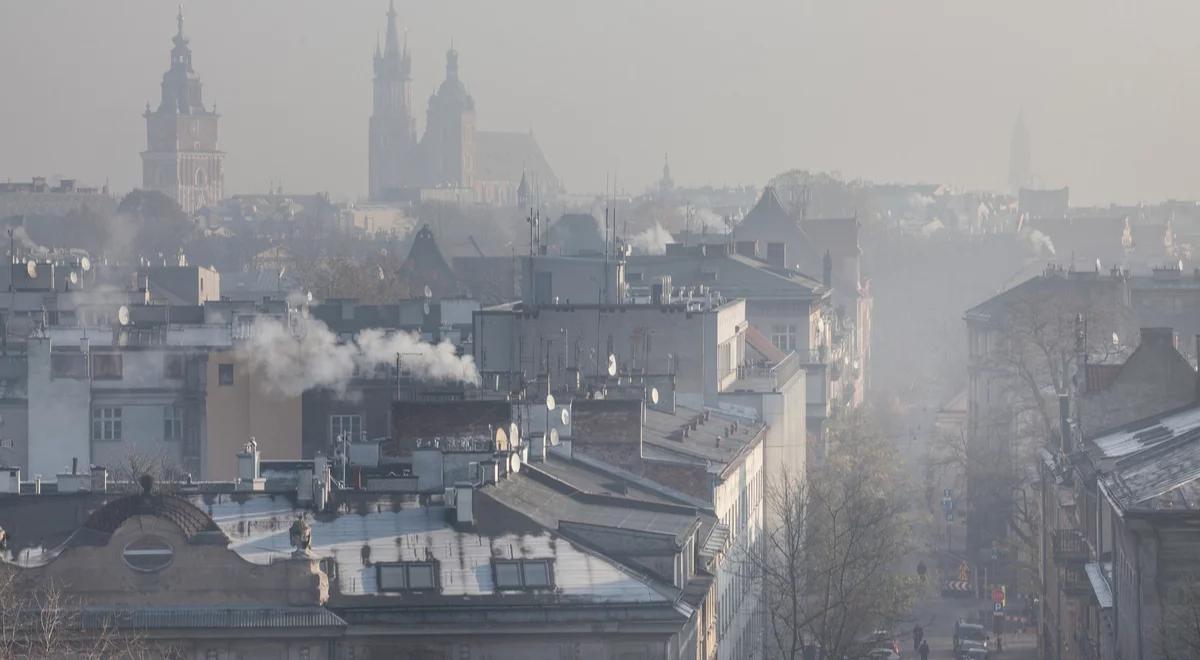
{"left": 239, "top": 316, "right": 480, "bottom": 396}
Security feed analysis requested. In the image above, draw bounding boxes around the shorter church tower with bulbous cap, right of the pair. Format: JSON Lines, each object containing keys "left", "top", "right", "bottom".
{"left": 421, "top": 46, "right": 475, "bottom": 187}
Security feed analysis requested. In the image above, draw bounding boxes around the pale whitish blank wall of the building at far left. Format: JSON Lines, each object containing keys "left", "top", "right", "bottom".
{"left": 28, "top": 338, "right": 91, "bottom": 481}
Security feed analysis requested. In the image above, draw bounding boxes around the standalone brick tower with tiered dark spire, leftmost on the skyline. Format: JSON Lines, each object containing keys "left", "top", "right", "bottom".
{"left": 142, "top": 10, "right": 224, "bottom": 214}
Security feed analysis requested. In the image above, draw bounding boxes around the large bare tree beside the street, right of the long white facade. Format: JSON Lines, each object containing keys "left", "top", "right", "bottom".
{"left": 754, "top": 415, "right": 918, "bottom": 660}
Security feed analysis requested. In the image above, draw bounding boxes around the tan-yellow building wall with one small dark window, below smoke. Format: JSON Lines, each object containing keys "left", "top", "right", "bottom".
{"left": 202, "top": 349, "right": 302, "bottom": 480}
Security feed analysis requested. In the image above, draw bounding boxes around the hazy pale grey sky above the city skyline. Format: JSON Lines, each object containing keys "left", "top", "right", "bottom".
{"left": 0, "top": 0, "right": 1200, "bottom": 203}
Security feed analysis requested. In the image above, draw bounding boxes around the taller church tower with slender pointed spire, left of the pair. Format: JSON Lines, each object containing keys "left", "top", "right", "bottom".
{"left": 368, "top": 4, "right": 416, "bottom": 199}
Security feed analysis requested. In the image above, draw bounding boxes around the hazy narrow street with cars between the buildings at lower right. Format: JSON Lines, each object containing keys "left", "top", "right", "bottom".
{"left": 892, "top": 404, "right": 1037, "bottom": 660}
